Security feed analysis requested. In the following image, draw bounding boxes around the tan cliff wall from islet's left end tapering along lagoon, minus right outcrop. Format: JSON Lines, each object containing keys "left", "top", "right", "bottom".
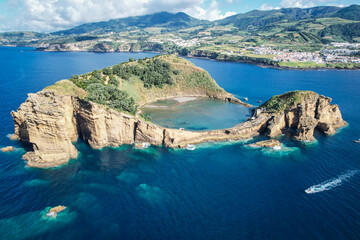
{"left": 11, "top": 90, "right": 268, "bottom": 167}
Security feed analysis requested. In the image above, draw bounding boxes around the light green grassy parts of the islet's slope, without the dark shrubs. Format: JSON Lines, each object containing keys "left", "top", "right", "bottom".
{"left": 44, "top": 55, "right": 229, "bottom": 105}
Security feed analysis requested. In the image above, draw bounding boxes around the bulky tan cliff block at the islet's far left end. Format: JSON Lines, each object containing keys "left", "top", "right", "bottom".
{"left": 11, "top": 92, "right": 78, "bottom": 167}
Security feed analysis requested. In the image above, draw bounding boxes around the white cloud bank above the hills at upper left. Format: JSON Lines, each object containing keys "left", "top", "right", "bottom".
{"left": 0, "top": 0, "right": 235, "bottom": 32}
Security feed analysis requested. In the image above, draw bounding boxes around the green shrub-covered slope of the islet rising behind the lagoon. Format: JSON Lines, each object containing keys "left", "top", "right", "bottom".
{"left": 53, "top": 55, "right": 228, "bottom": 115}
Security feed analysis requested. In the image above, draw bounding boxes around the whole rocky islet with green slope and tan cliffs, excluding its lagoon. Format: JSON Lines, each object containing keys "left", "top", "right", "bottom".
{"left": 12, "top": 55, "right": 346, "bottom": 167}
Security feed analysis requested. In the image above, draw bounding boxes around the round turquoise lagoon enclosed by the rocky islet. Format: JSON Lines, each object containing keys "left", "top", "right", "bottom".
{"left": 142, "top": 98, "right": 250, "bottom": 131}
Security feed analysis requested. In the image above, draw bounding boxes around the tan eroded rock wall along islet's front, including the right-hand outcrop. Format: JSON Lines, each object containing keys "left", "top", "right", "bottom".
{"left": 12, "top": 91, "right": 346, "bottom": 167}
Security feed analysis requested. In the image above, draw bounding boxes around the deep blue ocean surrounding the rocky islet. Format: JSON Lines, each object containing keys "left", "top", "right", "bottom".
{"left": 0, "top": 48, "right": 360, "bottom": 240}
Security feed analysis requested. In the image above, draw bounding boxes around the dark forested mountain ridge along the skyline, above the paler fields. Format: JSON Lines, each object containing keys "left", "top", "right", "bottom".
{"left": 52, "top": 5, "right": 360, "bottom": 35}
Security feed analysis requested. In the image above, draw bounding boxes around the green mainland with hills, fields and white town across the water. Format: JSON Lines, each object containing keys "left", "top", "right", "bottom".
{"left": 0, "top": 5, "right": 360, "bottom": 69}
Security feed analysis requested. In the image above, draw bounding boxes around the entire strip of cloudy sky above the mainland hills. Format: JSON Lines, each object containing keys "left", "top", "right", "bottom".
{"left": 0, "top": 0, "right": 360, "bottom": 32}
